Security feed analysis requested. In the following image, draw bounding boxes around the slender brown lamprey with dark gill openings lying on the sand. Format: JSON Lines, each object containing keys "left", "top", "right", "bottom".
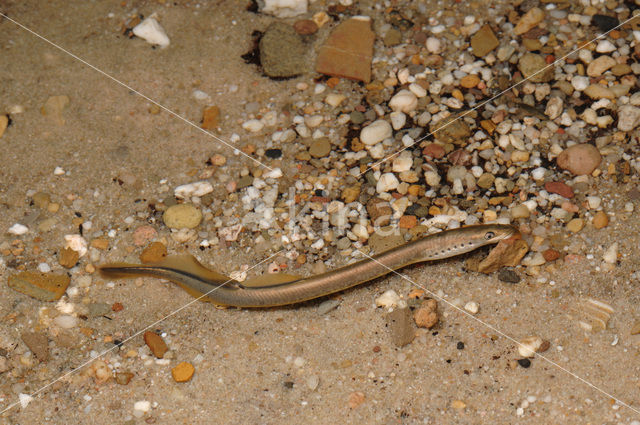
{"left": 100, "top": 224, "right": 519, "bottom": 307}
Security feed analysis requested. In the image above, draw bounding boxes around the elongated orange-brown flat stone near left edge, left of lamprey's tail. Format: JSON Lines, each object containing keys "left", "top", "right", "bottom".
{"left": 7, "top": 271, "right": 71, "bottom": 301}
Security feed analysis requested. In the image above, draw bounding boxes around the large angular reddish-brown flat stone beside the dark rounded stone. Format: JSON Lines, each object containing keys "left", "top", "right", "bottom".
{"left": 316, "top": 16, "right": 375, "bottom": 83}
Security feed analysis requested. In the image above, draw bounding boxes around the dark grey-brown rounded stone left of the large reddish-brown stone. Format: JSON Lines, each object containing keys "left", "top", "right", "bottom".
{"left": 258, "top": 22, "right": 307, "bottom": 78}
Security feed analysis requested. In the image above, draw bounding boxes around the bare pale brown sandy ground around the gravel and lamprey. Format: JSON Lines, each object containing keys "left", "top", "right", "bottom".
{"left": 0, "top": 1, "right": 640, "bottom": 424}
